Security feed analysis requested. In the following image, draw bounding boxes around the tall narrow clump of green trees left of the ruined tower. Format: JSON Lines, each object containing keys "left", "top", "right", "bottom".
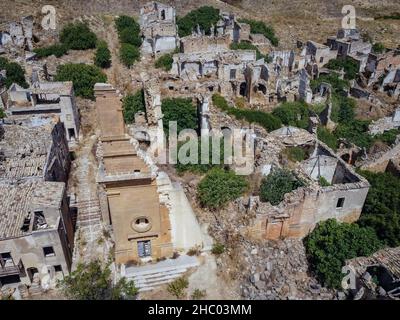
{"left": 115, "top": 15, "right": 142, "bottom": 68}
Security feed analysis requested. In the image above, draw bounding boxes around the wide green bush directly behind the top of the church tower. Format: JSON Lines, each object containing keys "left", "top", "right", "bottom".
{"left": 55, "top": 63, "right": 107, "bottom": 99}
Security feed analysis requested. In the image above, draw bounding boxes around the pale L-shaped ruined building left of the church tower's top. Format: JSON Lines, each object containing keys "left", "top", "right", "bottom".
{"left": 6, "top": 81, "right": 80, "bottom": 148}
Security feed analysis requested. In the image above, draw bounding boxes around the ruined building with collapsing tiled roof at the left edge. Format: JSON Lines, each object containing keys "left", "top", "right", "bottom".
{"left": 0, "top": 119, "right": 74, "bottom": 284}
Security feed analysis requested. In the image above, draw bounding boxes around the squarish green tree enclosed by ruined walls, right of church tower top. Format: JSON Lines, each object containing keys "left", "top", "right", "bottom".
{"left": 161, "top": 98, "right": 198, "bottom": 134}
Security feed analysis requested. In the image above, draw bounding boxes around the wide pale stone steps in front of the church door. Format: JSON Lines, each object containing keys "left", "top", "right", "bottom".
{"left": 121, "top": 256, "right": 199, "bottom": 292}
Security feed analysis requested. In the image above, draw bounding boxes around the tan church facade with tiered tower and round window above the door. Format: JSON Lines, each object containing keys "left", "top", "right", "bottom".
{"left": 95, "top": 84, "right": 172, "bottom": 264}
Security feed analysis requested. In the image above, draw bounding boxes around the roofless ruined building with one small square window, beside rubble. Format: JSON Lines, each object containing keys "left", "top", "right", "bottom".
{"left": 248, "top": 127, "right": 370, "bottom": 239}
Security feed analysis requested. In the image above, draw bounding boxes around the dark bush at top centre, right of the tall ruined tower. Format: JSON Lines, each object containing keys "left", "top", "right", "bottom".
{"left": 176, "top": 6, "right": 220, "bottom": 37}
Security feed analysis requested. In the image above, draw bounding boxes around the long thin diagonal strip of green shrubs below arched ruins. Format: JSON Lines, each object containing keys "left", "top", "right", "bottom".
{"left": 212, "top": 94, "right": 282, "bottom": 132}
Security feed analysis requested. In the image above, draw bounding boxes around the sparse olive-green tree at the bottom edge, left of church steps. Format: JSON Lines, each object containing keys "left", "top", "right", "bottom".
{"left": 59, "top": 260, "right": 138, "bottom": 300}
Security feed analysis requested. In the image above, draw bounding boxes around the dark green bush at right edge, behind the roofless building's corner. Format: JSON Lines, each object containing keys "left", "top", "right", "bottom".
{"left": 358, "top": 171, "right": 400, "bottom": 247}
